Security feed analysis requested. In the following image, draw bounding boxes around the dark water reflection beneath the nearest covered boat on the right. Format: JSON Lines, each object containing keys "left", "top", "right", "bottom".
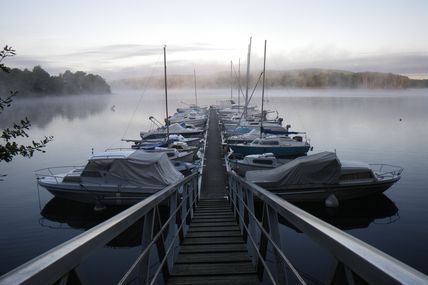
{"left": 280, "top": 194, "right": 400, "bottom": 232}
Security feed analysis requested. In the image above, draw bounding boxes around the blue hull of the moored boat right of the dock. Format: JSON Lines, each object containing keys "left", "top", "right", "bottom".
{"left": 229, "top": 145, "right": 310, "bottom": 157}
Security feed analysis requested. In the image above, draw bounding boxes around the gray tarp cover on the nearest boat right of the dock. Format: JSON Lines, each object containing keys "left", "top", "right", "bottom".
{"left": 245, "top": 152, "right": 341, "bottom": 186}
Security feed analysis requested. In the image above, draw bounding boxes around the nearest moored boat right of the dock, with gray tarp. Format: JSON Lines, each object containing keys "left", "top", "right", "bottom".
{"left": 245, "top": 152, "right": 403, "bottom": 202}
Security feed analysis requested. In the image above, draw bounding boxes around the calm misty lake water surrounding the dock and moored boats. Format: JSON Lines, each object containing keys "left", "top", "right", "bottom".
{"left": 0, "top": 89, "right": 428, "bottom": 284}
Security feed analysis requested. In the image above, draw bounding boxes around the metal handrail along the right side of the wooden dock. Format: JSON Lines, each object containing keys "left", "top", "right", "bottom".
{"left": 228, "top": 169, "right": 428, "bottom": 284}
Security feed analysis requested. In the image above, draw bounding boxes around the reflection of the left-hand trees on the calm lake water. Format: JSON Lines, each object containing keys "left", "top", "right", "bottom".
{"left": 0, "top": 95, "right": 110, "bottom": 128}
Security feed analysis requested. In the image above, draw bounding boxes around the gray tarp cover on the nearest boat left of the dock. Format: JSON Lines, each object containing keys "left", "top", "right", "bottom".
{"left": 109, "top": 150, "right": 183, "bottom": 189}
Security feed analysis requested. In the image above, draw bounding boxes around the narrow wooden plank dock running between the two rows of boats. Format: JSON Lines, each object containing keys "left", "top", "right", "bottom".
{"left": 167, "top": 109, "right": 260, "bottom": 284}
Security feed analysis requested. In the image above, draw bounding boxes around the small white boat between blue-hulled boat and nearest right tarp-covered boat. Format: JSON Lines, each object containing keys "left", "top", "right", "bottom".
{"left": 226, "top": 152, "right": 291, "bottom": 176}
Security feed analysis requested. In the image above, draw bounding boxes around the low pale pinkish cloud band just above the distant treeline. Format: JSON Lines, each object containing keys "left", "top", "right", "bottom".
{"left": 8, "top": 42, "right": 428, "bottom": 79}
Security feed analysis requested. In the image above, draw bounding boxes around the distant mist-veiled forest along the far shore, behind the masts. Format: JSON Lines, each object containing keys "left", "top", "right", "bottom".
{"left": 111, "top": 69, "right": 428, "bottom": 89}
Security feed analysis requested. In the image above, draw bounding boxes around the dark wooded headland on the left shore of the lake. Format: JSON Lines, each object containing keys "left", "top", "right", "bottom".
{"left": 0, "top": 66, "right": 111, "bottom": 96}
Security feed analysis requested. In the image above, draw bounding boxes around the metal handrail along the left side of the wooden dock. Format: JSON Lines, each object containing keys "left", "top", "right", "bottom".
{"left": 0, "top": 173, "right": 199, "bottom": 285}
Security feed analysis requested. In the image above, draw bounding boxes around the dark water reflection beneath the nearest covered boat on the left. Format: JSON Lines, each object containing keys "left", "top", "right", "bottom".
{"left": 40, "top": 197, "right": 172, "bottom": 247}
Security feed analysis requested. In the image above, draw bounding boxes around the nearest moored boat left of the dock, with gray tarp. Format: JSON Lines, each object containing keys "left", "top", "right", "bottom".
{"left": 35, "top": 150, "right": 183, "bottom": 205}
